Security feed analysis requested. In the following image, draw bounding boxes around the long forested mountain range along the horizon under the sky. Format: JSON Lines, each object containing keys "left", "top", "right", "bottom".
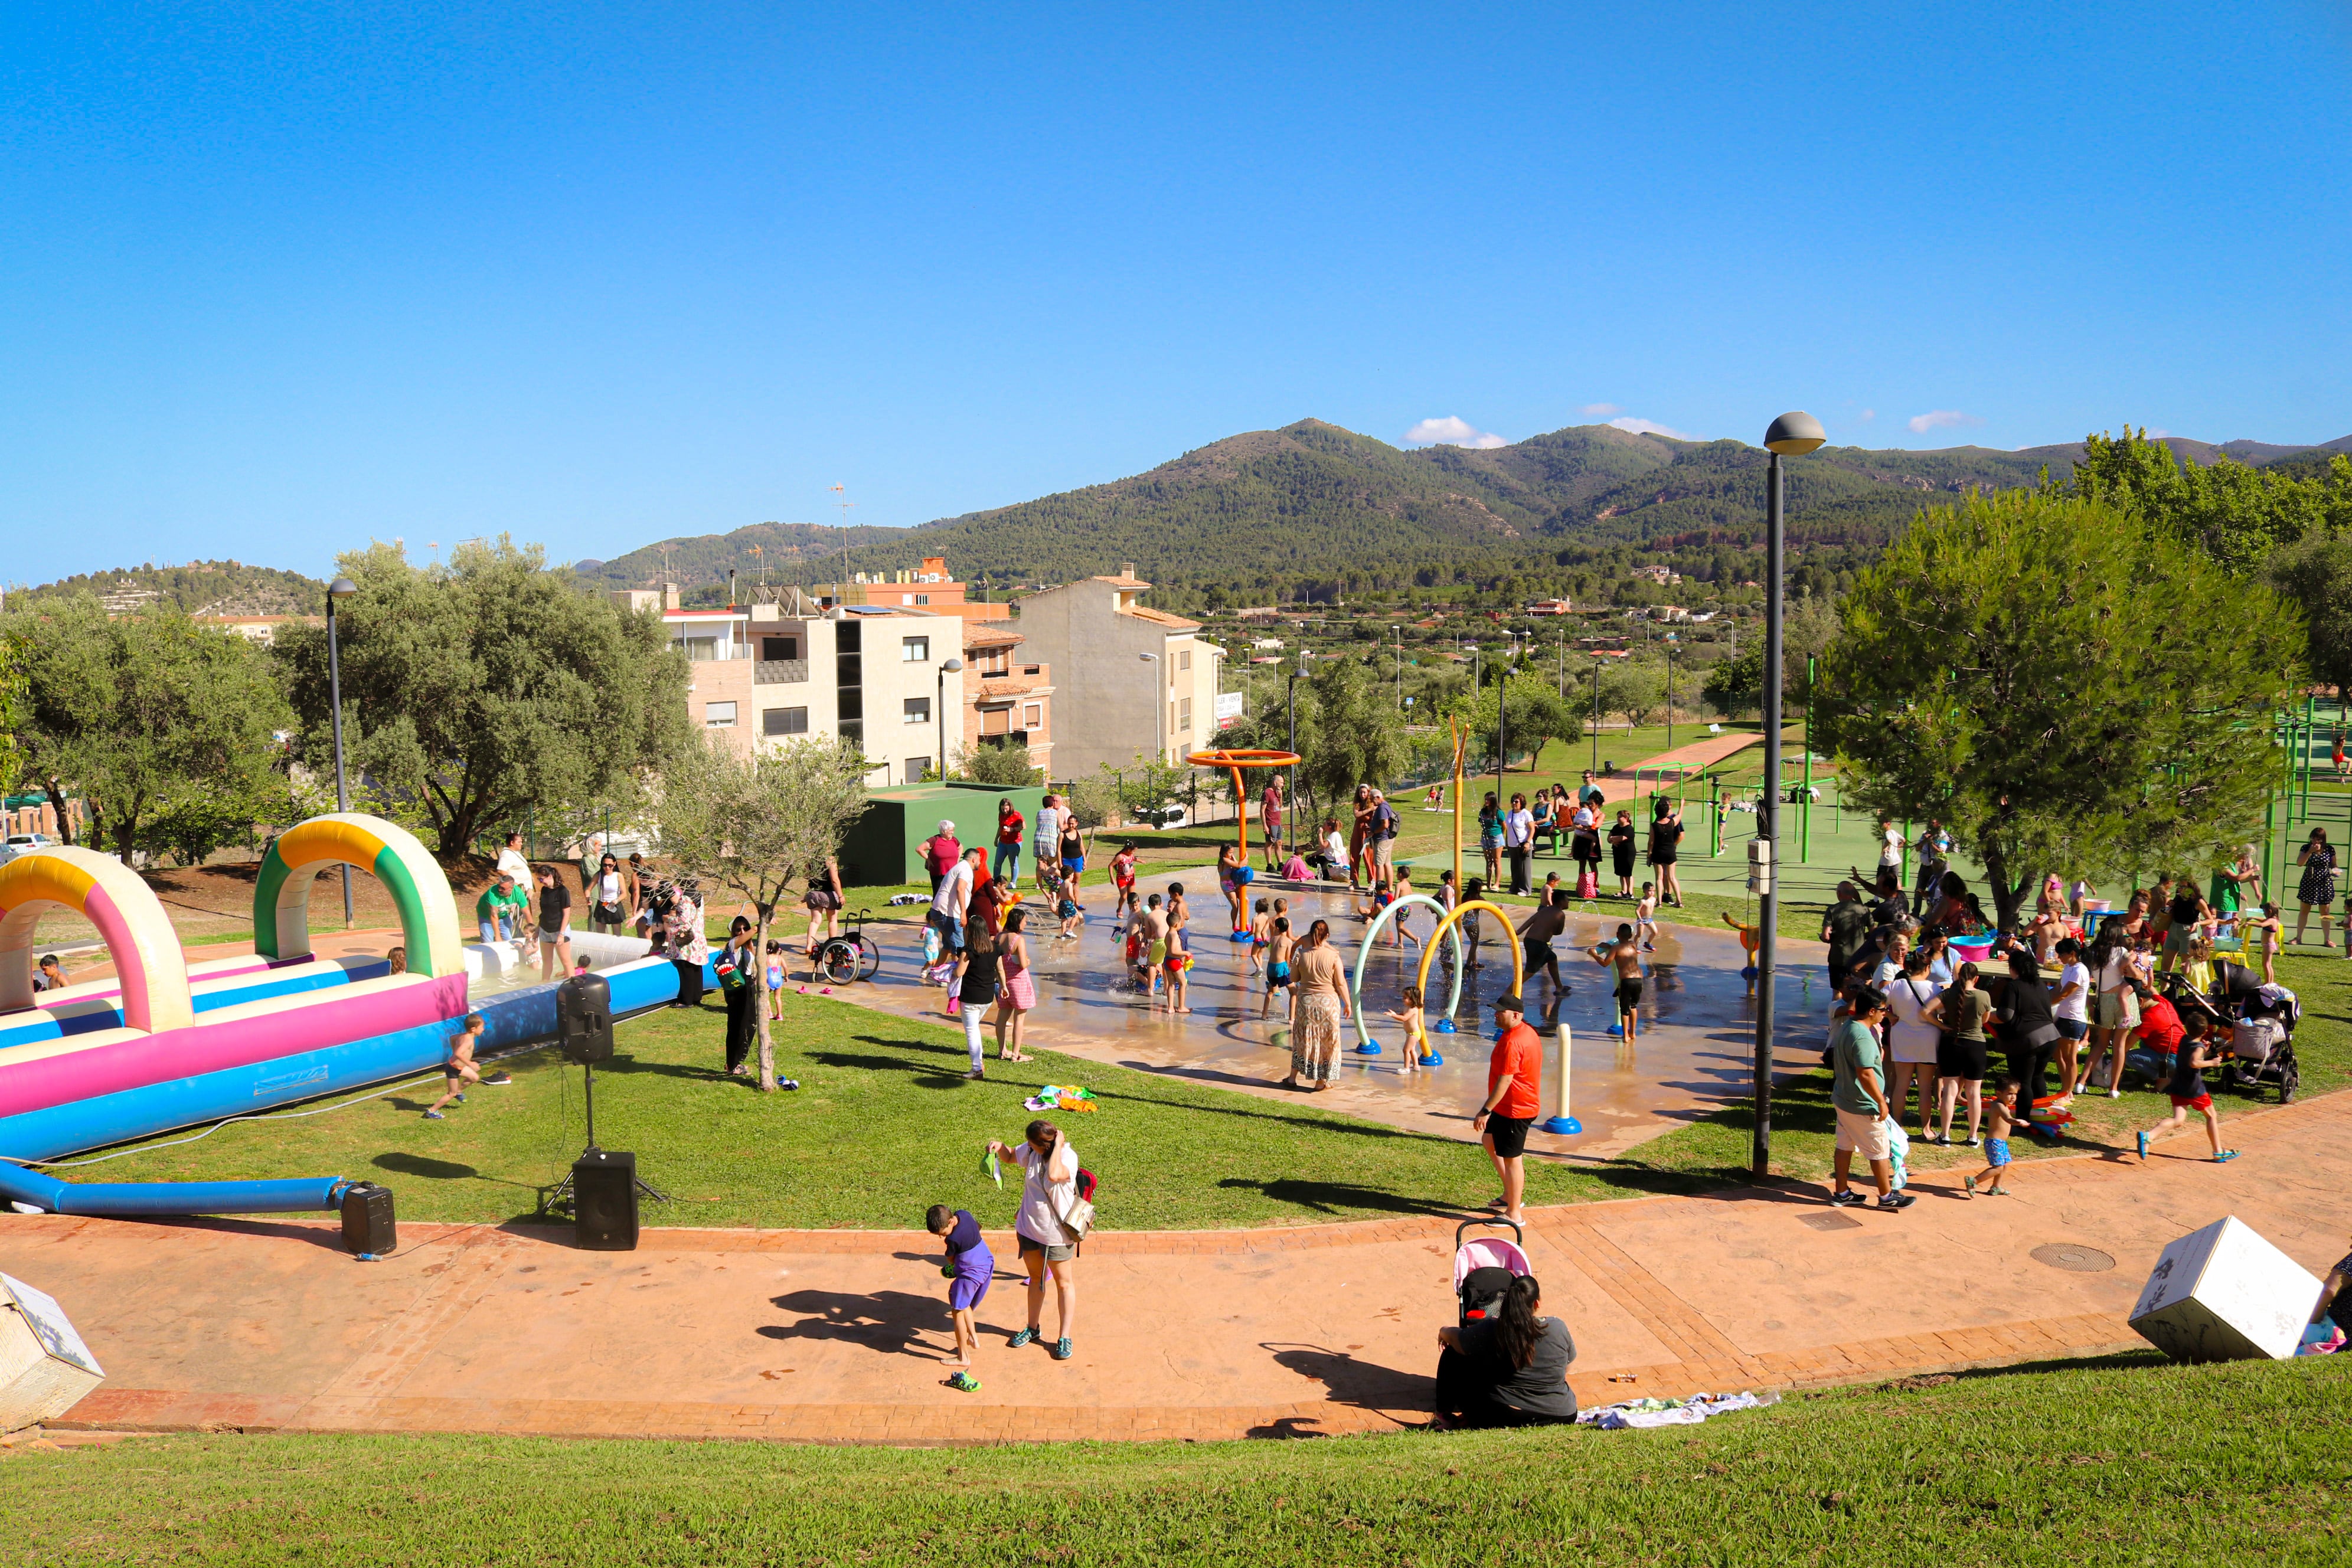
{"left": 576, "top": 419, "right": 2352, "bottom": 602}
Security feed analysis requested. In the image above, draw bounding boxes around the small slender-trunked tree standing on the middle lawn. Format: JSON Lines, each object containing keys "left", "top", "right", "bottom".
{"left": 659, "top": 740, "right": 865, "bottom": 1093}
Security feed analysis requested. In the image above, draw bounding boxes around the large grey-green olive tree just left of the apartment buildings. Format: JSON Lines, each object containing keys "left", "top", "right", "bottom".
{"left": 277, "top": 536, "right": 694, "bottom": 860}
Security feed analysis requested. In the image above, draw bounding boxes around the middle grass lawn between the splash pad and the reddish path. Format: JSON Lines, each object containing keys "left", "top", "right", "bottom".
{"left": 64, "top": 994, "right": 1745, "bottom": 1230}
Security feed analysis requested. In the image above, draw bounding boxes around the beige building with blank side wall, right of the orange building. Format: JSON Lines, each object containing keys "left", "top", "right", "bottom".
{"left": 1014, "top": 562, "right": 1226, "bottom": 778}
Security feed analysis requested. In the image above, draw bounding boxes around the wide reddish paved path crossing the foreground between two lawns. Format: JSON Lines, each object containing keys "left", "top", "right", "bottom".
{"left": 0, "top": 1096, "right": 2352, "bottom": 1443}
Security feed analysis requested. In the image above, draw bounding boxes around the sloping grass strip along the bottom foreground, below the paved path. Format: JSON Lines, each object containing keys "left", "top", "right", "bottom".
{"left": 0, "top": 1357, "right": 2352, "bottom": 1568}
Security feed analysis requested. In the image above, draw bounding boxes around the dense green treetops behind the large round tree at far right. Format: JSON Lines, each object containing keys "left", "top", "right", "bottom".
{"left": 2049, "top": 426, "right": 2352, "bottom": 576}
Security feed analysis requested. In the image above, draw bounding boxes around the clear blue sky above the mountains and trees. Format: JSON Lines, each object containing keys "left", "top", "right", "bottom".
{"left": 0, "top": 0, "right": 2352, "bottom": 583}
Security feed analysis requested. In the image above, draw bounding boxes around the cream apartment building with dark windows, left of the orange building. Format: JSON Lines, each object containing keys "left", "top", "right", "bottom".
{"left": 614, "top": 590, "right": 1021, "bottom": 785}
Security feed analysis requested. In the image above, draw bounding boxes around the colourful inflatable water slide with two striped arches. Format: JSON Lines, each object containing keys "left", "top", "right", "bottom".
{"left": 0, "top": 814, "right": 708, "bottom": 1216}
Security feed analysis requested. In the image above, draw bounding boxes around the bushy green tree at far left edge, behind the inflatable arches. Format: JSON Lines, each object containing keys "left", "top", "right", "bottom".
{"left": 7, "top": 594, "right": 289, "bottom": 860}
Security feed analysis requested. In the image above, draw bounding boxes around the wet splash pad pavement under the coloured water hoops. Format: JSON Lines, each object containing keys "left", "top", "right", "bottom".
{"left": 835, "top": 872, "right": 1828, "bottom": 1159}
